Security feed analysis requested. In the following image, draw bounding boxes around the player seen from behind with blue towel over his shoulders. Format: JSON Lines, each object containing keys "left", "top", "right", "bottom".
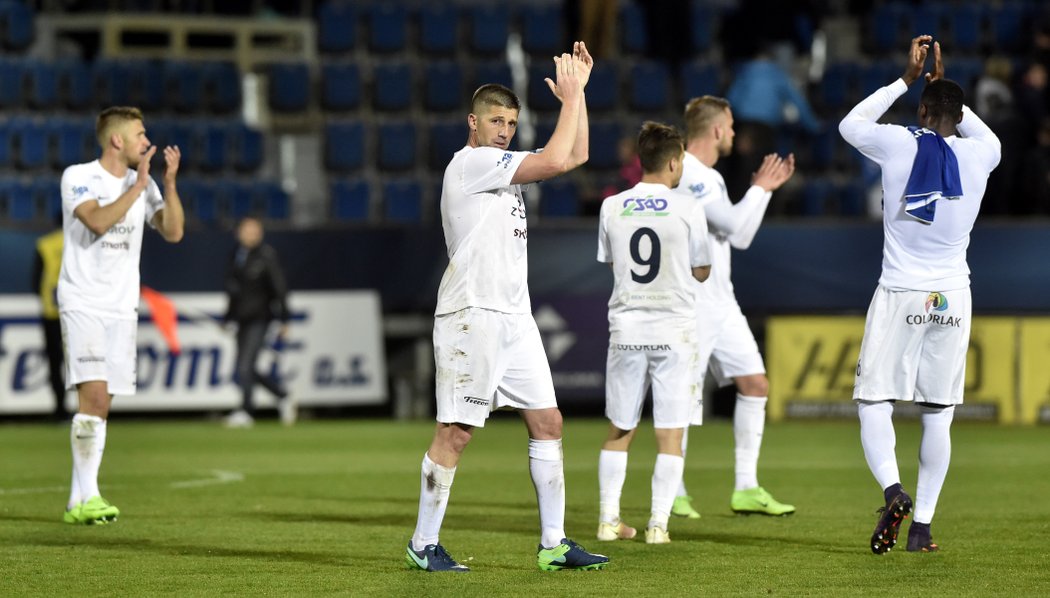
{"left": 839, "top": 36, "right": 1001, "bottom": 554}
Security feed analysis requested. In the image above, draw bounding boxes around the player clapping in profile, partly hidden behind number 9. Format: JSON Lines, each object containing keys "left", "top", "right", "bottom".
{"left": 673, "top": 95, "right": 795, "bottom": 519}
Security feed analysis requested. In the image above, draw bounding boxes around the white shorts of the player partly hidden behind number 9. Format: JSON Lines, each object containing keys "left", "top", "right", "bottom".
{"left": 696, "top": 302, "right": 765, "bottom": 386}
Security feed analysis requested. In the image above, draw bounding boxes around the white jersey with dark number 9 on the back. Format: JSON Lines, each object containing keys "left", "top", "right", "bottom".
{"left": 597, "top": 183, "right": 711, "bottom": 343}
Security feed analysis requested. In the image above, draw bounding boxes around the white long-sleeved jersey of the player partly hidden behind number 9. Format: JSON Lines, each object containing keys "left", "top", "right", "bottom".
{"left": 675, "top": 152, "right": 773, "bottom": 304}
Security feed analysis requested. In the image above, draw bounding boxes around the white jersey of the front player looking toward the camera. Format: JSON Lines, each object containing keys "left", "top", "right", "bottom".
{"left": 436, "top": 147, "right": 532, "bottom": 316}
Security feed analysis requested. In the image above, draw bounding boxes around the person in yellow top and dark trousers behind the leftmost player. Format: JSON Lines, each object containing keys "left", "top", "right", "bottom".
{"left": 33, "top": 211, "right": 69, "bottom": 421}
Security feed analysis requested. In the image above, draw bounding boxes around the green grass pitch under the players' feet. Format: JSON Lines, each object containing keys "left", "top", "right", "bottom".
{"left": 0, "top": 417, "right": 1050, "bottom": 597}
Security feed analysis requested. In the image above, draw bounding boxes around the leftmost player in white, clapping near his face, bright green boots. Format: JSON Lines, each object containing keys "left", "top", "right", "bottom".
{"left": 58, "top": 107, "right": 185, "bottom": 525}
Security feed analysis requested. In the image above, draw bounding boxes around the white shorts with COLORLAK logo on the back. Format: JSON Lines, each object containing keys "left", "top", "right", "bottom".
{"left": 854, "top": 285, "right": 971, "bottom": 405}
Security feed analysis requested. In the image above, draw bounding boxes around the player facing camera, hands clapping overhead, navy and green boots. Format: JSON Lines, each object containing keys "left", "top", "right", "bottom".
{"left": 405, "top": 42, "right": 609, "bottom": 572}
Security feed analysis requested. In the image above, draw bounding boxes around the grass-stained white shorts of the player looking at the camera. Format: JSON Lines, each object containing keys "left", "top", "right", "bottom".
{"left": 434, "top": 307, "right": 558, "bottom": 427}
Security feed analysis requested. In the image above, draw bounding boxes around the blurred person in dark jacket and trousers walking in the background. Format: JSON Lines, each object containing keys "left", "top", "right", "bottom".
{"left": 226, "top": 216, "right": 297, "bottom": 428}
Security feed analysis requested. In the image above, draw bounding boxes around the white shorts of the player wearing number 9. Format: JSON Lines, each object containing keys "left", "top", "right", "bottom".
{"left": 605, "top": 342, "right": 704, "bottom": 430}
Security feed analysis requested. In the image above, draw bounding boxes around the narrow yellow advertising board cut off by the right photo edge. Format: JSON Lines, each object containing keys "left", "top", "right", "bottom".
{"left": 1017, "top": 318, "right": 1050, "bottom": 424}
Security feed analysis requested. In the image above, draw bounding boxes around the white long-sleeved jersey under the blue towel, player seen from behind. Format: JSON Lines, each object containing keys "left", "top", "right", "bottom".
{"left": 839, "top": 79, "right": 1001, "bottom": 291}
